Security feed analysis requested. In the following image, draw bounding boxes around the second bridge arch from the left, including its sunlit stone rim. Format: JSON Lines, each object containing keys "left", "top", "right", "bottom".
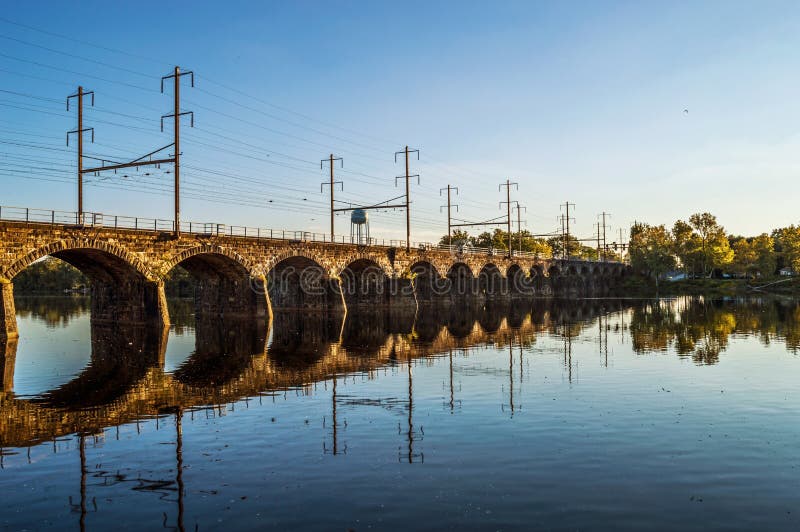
{"left": 162, "top": 244, "right": 269, "bottom": 318}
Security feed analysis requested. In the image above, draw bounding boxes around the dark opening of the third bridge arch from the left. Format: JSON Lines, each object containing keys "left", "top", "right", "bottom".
{"left": 267, "top": 256, "right": 344, "bottom": 311}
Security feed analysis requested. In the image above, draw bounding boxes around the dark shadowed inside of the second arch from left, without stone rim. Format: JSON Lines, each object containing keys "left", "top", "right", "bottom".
{"left": 168, "top": 252, "right": 269, "bottom": 319}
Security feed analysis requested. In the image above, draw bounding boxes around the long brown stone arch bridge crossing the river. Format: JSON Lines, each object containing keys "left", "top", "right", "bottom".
{"left": 0, "top": 221, "right": 625, "bottom": 338}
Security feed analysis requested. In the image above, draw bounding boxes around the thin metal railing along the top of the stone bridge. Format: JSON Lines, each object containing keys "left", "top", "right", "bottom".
{"left": 0, "top": 206, "right": 611, "bottom": 262}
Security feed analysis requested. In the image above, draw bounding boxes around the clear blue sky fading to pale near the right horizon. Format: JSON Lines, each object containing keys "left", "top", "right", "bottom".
{"left": 0, "top": 1, "right": 800, "bottom": 240}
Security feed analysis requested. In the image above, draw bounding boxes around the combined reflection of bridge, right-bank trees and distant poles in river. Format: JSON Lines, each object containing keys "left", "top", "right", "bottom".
{"left": 0, "top": 298, "right": 800, "bottom": 450}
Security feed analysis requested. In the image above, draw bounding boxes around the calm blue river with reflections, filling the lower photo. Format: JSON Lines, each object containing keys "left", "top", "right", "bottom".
{"left": 0, "top": 297, "right": 800, "bottom": 530}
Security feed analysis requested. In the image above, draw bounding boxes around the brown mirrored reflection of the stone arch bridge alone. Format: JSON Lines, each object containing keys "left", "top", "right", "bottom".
{"left": 0, "top": 300, "right": 622, "bottom": 447}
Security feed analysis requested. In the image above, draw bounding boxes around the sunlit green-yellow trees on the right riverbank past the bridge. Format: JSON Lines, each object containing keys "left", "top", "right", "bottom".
{"left": 630, "top": 212, "right": 800, "bottom": 284}
